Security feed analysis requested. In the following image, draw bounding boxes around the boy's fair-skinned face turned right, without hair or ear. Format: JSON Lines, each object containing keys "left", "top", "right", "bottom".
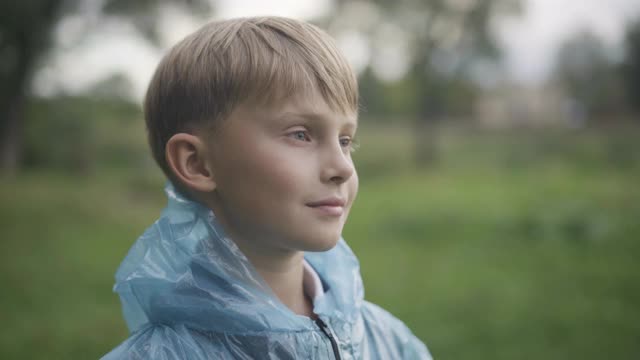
{"left": 205, "top": 91, "right": 358, "bottom": 255}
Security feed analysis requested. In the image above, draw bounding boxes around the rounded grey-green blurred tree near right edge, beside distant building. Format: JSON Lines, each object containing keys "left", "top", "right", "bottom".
{"left": 552, "top": 31, "right": 624, "bottom": 120}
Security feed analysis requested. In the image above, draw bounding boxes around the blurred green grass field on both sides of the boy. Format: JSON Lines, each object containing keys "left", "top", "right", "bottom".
{"left": 0, "top": 124, "right": 640, "bottom": 360}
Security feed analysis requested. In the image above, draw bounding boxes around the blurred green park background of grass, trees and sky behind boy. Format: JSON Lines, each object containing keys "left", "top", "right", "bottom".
{"left": 0, "top": 0, "right": 640, "bottom": 360}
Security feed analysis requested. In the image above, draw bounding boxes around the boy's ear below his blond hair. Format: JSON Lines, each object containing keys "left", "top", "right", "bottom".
{"left": 165, "top": 133, "right": 216, "bottom": 192}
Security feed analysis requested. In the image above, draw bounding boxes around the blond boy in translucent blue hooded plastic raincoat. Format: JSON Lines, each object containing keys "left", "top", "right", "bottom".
{"left": 104, "top": 17, "right": 431, "bottom": 359}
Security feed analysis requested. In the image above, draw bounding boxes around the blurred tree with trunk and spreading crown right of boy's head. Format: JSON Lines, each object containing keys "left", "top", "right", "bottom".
{"left": 324, "top": 0, "right": 521, "bottom": 165}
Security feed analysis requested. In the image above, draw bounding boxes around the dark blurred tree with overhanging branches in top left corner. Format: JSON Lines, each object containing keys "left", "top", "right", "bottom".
{"left": 0, "top": 0, "right": 211, "bottom": 174}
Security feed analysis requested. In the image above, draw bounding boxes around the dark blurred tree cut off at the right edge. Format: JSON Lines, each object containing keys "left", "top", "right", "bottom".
{"left": 622, "top": 19, "right": 640, "bottom": 113}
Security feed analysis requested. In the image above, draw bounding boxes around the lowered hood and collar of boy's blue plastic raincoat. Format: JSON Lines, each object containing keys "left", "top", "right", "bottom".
{"left": 114, "top": 183, "right": 364, "bottom": 333}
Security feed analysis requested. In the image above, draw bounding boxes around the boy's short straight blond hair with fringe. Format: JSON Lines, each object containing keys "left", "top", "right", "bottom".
{"left": 144, "top": 17, "right": 358, "bottom": 179}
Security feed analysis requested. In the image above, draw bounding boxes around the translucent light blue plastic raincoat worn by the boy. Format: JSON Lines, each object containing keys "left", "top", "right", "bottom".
{"left": 103, "top": 184, "right": 431, "bottom": 360}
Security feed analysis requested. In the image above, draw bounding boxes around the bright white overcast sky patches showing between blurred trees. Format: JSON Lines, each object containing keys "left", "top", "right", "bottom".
{"left": 36, "top": 0, "right": 640, "bottom": 98}
